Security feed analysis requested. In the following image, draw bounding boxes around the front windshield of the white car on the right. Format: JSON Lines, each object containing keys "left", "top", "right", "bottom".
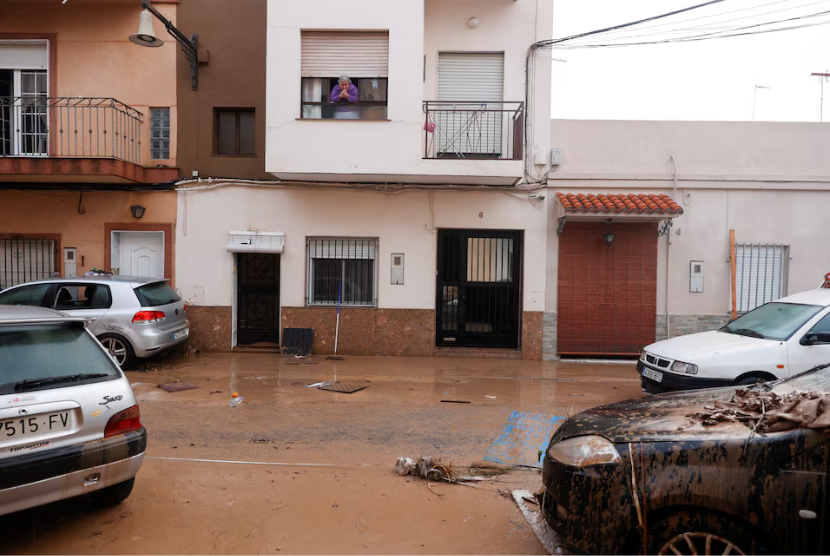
{"left": 721, "top": 303, "right": 822, "bottom": 340}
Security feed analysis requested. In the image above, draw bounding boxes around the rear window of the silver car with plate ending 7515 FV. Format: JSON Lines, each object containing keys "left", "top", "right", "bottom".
{"left": 0, "top": 323, "right": 121, "bottom": 395}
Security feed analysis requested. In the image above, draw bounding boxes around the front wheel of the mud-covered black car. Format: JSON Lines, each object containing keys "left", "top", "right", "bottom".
{"left": 648, "top": 512, "right": 766, "bottom": 556}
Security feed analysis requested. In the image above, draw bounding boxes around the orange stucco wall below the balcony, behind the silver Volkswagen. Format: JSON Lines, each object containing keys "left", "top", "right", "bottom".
{"left": 0, "top": 191, "right": 176, "bottom": 274}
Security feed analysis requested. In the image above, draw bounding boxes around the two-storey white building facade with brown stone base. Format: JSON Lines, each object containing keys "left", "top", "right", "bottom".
{"left": 176, "top": 0, "right": 553, "bottom": 359}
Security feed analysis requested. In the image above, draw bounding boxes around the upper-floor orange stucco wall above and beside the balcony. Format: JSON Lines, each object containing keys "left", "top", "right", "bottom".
{"left": 0, "top": 0, "right": 180, "bottom": 166}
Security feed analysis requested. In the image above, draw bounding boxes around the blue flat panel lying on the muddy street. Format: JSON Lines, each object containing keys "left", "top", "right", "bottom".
{"left": 484, "top": 411, "right": 565, "bottom": 468}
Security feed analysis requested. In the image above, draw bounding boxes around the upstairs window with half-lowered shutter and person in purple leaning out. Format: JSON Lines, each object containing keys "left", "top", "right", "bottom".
{"left": 301, "top": 31, "right": 389, "bottom": 120}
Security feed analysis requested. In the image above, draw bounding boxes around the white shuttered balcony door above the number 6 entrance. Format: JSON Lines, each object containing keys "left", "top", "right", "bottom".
{"left": 434, "top": 52, "right": 507, "bottom": 158}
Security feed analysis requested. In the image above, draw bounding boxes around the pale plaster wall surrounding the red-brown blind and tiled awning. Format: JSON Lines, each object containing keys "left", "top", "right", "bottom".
{"left": 546, "top": 120, "right": 830, "bottom": 315}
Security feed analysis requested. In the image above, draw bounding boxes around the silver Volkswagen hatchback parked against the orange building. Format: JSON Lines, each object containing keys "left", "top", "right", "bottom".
{"left": 0, "top": 276, "right": 190, "bottom": 367}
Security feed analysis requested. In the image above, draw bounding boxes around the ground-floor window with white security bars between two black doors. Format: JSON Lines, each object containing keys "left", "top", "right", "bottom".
{"left": 306, "top": 239, "right": 377, "bottom": 307}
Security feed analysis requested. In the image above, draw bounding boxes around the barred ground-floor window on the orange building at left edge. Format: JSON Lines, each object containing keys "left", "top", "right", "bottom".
{"left": 0, "top": 235, "right": 58, "bottom": 291}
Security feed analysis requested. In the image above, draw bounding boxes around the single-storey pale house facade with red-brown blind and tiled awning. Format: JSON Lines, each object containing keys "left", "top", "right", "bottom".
{"left": 543, "top": 120, "right": 830, "bottom": 359}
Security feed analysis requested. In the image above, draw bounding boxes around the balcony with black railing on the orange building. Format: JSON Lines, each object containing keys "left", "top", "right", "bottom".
{"left": 0, "top": 95, "right": 178, "bottom": 183}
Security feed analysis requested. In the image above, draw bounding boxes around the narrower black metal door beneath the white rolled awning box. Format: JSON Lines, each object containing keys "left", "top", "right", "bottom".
{"left": 236, "top": 253, "right": 280, "bottom": 345}
